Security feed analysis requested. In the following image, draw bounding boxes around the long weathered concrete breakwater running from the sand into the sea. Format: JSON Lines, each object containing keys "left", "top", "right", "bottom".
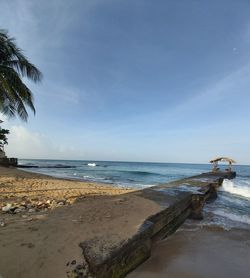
{"left": 76, "top": 171, "right": 236, "bottom": 278}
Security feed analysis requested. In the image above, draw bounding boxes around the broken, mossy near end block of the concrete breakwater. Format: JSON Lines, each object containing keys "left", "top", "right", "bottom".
{"left": 80, "top": 221, "right": 153, "bottom": 277}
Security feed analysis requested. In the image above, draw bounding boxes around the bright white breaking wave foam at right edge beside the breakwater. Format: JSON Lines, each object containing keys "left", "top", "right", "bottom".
{"left": 222, "top": 180, "right": 250, "bottom": 198}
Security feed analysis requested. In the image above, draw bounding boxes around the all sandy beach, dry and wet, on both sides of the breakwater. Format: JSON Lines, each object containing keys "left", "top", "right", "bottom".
{"left": 0, "top": 168, "right": 250, "bottom": 278}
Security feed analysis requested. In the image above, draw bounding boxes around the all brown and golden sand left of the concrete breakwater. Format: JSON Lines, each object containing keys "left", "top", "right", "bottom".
{"left": 0, "top": 168, "right": 159, "bottom": 278}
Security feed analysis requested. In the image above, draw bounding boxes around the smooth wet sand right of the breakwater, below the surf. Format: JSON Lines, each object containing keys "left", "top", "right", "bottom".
{"left": 127, "top": 222, "right": 250, "bottom": 278}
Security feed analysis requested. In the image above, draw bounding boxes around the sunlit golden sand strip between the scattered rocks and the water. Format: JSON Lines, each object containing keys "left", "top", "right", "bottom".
{"left": 0, "top": 167, "right": 134, "bottom": 210}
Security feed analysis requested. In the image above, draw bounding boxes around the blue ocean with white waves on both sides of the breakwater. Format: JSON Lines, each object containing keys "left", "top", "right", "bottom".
{"left": 19, "top": 159, "right": 250, "bottom": 230}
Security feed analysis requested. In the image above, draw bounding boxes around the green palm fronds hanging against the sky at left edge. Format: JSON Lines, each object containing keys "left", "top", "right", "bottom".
{"left": 0, "top": 30, "right": 42, "bottom": 121}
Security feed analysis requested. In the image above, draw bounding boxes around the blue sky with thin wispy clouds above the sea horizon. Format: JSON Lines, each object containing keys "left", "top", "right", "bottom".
{"left": 0, "top": 0, "right": 250, "bottom": 164}
